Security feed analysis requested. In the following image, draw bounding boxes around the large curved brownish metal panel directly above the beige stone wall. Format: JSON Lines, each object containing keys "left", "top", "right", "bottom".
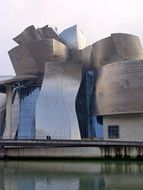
{"left": 95, "top": 61, "right": 143, "bottom": 115}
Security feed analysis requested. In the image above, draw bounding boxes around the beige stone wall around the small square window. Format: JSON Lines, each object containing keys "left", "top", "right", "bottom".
{"left": 103, "top": 114, "right": 143, "bottom": 141}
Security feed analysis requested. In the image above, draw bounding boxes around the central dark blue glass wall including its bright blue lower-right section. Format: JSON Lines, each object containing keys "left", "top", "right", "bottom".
{"left": 76, "top": 70, "right": 103, "bottom": 138}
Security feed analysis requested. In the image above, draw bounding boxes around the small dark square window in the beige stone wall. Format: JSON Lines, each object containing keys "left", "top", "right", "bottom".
{"left": 108, "top": 125, "right": 119, "bottom": 138}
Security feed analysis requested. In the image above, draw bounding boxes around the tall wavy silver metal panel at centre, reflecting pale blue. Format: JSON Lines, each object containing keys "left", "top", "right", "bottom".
{"left": 36, "top": 62, "right": 81, "bottom": 139}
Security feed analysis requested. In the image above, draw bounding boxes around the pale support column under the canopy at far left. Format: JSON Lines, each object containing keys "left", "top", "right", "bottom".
{"left": 3, "top": 85, "right": 12, "bottom": 139}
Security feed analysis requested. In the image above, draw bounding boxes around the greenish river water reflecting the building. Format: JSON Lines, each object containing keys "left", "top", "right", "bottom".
{"left": 0, "top": 161, "right": 143, "bottom": 190}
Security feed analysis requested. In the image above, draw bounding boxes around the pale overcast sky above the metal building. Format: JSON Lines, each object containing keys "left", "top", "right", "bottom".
{"left": 0, "top": 0, "right": 143, "bottom": 75}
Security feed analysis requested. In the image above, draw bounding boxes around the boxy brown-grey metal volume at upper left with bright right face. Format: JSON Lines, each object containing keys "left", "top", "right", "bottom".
{"left": 9, "top": 39, "right": 68, "bottom": 75}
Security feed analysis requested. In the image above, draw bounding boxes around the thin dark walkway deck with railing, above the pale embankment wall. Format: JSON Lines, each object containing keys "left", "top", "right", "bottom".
{"left": 0, "top": 139, "right": 143, "bottom": 147}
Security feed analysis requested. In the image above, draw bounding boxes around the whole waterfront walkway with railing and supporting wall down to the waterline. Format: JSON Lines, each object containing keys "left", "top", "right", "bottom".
{"left": 0, "top": 139, "right": 143, "bottom": 160}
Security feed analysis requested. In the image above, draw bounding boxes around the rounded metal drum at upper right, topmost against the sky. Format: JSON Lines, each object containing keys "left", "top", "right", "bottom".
{"left": 92, "top": 33, "right": 143, "bottom": 67}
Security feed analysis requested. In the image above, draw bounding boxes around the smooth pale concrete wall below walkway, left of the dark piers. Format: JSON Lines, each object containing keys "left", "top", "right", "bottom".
{"left": 5, "top": 147, "right": 101, "bottom": 158}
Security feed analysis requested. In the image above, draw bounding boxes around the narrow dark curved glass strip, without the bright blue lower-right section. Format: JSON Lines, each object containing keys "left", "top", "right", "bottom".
{"left": 76, "top": 71, "right": 96, "bottom": 138}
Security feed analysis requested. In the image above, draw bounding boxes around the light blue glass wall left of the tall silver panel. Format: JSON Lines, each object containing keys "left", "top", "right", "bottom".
{"left": 17, "top": 86, "right": 40, "bottom": 139}
